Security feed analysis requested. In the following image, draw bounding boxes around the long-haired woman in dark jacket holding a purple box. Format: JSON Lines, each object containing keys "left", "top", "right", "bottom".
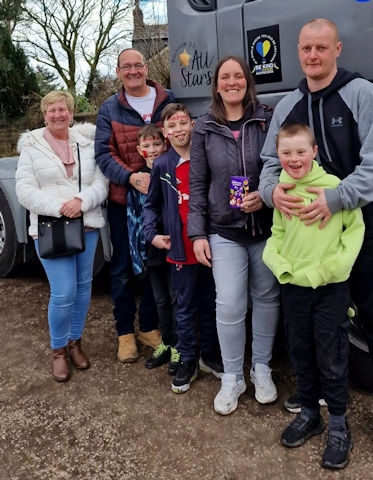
{"left": 188, "top": 56, "right": 279, "bottom": 415}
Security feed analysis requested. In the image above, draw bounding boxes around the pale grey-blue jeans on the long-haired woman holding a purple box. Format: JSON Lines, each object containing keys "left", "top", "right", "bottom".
{"left": 209, "top": 234, "right": 280, "bottom": 375}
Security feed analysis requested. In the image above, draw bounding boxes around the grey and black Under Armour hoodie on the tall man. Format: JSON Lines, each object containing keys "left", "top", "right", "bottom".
{"left": 259, "top": 68, "right": 373, "bottom": 237}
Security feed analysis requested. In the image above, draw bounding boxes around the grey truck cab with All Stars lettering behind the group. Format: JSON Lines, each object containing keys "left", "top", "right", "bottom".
{"left": 167, "top": 0, "right": 373, "bottom": 391}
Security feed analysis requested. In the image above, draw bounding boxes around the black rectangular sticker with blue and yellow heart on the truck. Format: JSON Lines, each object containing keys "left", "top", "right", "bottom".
{"left": 247, "top": 25, "right": 282, "bottom": 84}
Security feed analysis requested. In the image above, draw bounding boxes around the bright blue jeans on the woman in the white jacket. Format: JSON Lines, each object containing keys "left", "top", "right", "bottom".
{"left": 35, "top": 230, "right": 99, "bottom": 350}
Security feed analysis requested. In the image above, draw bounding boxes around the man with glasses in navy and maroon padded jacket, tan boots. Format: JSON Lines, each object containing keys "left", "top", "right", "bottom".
{"left": 95, "top": 48, "right": 175, "bottom": 363}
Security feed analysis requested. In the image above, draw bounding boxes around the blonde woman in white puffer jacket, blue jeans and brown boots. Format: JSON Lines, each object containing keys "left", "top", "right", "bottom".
{"left": 16, "top": 91, "right": 108, "bottom": 382}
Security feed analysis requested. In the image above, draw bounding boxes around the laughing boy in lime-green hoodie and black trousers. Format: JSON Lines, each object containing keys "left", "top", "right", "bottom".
{"left": 263, "top": 123, "right": 365, "bottom": 469}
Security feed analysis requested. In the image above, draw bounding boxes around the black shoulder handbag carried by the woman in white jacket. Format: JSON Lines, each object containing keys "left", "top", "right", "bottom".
{"left": 38, "top": 145, "right": 85, "bottom": 258}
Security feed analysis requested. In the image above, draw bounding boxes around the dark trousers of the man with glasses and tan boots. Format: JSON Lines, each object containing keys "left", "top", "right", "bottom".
{"left": 108, "top": 201, "right": 158, "bottom": 336}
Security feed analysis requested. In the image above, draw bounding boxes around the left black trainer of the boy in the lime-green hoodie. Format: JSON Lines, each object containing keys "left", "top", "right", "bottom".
{"left": 281, "top": 413, "right": 325, "bottom": 448}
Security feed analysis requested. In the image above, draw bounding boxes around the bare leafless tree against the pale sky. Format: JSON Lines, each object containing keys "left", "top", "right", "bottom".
{"left": 17, "top": 0, "right": 134, "bottom": 98}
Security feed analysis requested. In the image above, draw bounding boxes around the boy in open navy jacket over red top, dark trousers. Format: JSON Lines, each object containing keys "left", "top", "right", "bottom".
{"left": 144, "top": 103, "right": 223, "bottom": 393}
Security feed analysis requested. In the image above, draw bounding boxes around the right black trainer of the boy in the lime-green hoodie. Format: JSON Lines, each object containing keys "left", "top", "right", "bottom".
{"left": 321, "top": 426, "right": 353, "bottom": 470}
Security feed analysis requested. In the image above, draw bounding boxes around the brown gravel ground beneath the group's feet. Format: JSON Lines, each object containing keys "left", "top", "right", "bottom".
{"left": 0, "top": 268, "right": 373, "bottom": 480}
